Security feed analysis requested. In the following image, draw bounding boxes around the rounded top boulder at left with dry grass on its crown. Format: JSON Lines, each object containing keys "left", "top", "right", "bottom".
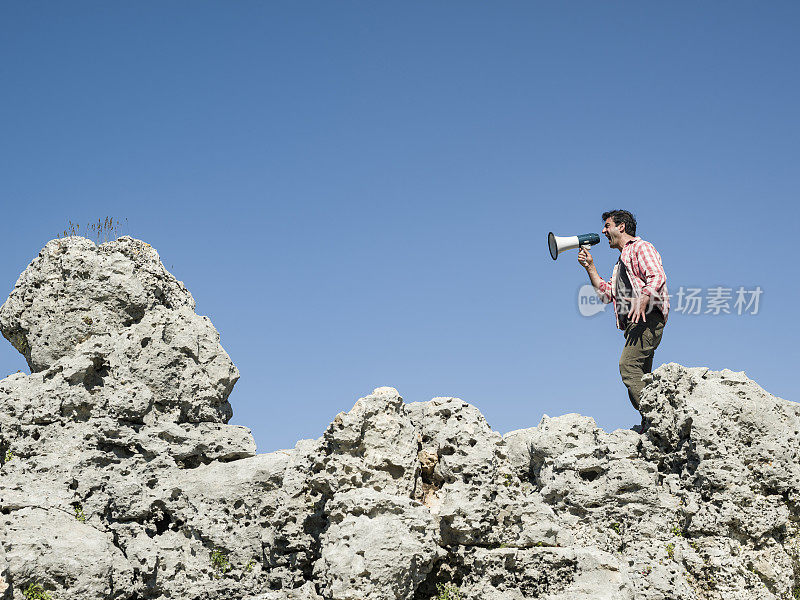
{"left": 0, "top": 236, "right": 194, "bottom": 371}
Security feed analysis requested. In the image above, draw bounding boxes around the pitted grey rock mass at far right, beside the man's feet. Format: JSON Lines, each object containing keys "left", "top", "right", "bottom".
{"left": 641, "top": 364, "right": 800, "bottom": 598}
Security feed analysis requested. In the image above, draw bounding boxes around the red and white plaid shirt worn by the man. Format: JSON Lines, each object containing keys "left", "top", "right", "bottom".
{"left": 597, "top": 237, "right": 669, "bottom": 329}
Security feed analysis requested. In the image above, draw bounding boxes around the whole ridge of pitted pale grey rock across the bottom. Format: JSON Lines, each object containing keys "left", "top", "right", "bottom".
{"left": 0, "top": 237, "right": 800, "bottom": 600}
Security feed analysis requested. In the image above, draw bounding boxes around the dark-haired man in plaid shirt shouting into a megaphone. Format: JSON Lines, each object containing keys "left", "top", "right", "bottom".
{"left": 578, "top": 210, "right": 669, "bottom": 410}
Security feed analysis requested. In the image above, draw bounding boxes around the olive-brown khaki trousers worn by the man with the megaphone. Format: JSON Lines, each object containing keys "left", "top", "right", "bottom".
{"left": 619, "top": 308, "right": 664, "bottom": 410}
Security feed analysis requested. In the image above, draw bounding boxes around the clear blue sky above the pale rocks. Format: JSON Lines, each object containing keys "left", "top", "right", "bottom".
{"left": 0, "top": 0, "right": 800, "bottom": 451}
